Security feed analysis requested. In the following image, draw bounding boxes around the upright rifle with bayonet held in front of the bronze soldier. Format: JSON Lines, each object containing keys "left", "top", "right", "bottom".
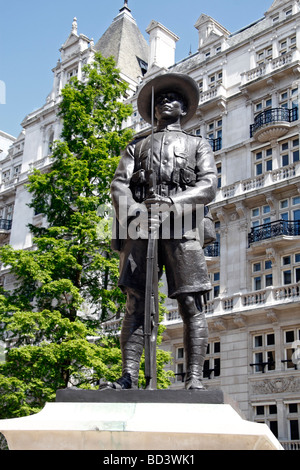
{"left": 144, "top": 87, "right": 159, "bottom": 390}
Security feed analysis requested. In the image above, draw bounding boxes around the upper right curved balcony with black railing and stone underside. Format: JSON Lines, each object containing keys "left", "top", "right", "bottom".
{"left": 250, "top": 108, "right": 298, "bottom": 142}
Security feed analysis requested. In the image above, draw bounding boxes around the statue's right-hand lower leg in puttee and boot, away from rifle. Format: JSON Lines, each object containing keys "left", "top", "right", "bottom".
{"left": 178, "top": 294, "right": 208, "bottom": 390}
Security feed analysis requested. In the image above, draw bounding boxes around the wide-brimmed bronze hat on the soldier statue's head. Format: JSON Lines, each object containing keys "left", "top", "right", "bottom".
{"left": 137, "top": 73, "right": 199, "bottom": 124}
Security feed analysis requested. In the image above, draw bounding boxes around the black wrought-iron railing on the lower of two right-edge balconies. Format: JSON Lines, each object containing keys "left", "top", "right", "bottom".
{"left": 248, "top": 220, "right": 300, "bottom": 245}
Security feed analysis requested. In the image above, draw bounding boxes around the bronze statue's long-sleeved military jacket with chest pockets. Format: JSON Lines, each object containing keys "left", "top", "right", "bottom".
{"left": 111, "top": 125, "right": 217, "bottom": 250}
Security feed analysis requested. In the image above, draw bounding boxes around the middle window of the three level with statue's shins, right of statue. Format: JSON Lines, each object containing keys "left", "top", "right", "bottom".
{"left": 250, "top": 332, "right": 275, "bottom": 373}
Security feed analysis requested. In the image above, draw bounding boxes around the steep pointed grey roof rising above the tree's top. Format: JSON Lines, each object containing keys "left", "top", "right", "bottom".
{"left": 95, "top": 3, "right": 149, "bottom": 83}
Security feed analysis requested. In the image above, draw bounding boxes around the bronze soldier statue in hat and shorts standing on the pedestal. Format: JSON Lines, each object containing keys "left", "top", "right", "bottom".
{"left": 106, "top": 73, "right": 217, "bottom": 390}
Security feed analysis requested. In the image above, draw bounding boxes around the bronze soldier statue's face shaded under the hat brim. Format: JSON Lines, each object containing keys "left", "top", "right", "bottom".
{"left": 155, "top": 93, "right": 186, "bottom": 122}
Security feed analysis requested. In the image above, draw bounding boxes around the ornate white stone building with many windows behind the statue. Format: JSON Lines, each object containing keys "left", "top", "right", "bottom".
{"left": 0, "top": 0, "right": 300, "bottom": 448}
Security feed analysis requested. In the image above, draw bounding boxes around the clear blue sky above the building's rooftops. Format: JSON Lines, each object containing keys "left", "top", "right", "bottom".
{"left": 0, "top": 0, "right": 273, "bottom": 137}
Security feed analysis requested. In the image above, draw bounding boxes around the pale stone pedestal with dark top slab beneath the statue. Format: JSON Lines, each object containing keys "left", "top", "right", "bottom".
{"left": 0, "top": 389, "right": 282, "bottom": 451}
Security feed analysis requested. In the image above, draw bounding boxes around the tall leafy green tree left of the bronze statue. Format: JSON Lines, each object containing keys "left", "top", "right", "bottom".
{"left": 0, "top": 54, "right": 169, "bottom": 418}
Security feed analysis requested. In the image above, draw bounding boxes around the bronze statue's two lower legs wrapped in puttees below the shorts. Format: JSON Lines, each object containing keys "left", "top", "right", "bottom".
{"left": 121, "top": 289, "right": 208, "bottom": 388}
